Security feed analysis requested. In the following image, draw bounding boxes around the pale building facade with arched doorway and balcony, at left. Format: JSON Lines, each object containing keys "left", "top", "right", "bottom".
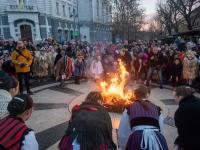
{"left": 0, "top": 0, "right": 78, "bottom": 42}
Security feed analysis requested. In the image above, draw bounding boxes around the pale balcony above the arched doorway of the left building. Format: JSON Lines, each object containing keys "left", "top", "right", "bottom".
{"left": 6, "top": 5, "right": 38, "bottom": 12}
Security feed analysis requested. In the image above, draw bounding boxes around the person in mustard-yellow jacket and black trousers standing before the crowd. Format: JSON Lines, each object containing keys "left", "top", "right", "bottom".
{"left": 11, "top": 41, "right": 33, "bottom": 95}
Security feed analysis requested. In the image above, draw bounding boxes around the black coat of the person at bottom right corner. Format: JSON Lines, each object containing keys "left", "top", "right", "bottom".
{"left": 175, "top": 95, "right": 200, "bottom": 150}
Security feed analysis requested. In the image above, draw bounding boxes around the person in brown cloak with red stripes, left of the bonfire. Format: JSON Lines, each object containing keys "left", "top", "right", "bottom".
{"left": 55, "top": 55, "right": 72, "bottom": 88}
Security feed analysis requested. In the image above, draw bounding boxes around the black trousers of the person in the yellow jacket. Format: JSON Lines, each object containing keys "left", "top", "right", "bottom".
{"left": 17, "top": 72, "right": 30, "bottom": 93}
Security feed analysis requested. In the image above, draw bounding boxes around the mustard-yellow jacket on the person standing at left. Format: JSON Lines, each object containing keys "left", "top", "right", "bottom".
{"left": 11, "top": 49, "right": 33, "bottom": 73}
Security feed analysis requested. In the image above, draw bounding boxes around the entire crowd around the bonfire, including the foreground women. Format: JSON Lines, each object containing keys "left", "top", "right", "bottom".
{"left": 0, "top": 38, "right": 200, "bottom": 150}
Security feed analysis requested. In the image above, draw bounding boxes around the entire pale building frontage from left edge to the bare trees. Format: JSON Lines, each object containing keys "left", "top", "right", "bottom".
{"left": 0, "top": 0, "right": 111, "bottom": 42}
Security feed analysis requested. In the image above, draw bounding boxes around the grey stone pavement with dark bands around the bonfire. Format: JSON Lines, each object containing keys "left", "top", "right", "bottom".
{"left": 27, "top": 81, "right": 186, "bottom": 150}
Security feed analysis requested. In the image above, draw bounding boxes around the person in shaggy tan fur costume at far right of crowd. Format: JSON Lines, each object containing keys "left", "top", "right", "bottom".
{"left": 183, "top": 50, "right": 198, "bottom": 85}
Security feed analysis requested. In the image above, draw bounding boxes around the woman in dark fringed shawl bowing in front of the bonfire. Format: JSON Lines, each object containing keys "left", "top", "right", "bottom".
{"left": 58, "top": 92, "right": 116, "bottom": 150}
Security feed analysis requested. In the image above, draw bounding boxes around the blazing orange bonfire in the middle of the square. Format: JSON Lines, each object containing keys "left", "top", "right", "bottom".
{"left": 99, "top": 60, "right": 134, "bottom": 113}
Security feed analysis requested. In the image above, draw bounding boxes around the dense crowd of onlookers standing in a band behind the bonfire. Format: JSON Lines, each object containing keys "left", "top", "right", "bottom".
{"left": 0, "top": 38, "right": 200, "bottom": 93}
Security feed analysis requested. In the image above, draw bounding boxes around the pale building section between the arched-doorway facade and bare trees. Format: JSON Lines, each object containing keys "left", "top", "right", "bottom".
{"left": 78, "top": 0, "right": 112, "bottom": 42}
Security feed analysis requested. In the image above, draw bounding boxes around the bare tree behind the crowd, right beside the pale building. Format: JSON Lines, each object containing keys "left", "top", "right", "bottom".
{"left": 113, "top": 0, "right": 144, "bottom": 40}
